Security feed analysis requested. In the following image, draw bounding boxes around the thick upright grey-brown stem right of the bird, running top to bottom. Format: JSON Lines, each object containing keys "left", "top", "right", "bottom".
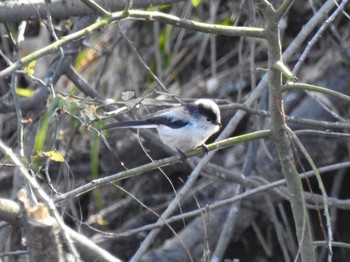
{"left": 255, "top": 0, "right": 316, "bottom": 261}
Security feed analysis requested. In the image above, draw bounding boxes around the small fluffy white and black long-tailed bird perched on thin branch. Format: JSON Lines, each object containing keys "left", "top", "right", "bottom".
{"left": 103, "top": 99, "right": 221, "bottom": 152}
